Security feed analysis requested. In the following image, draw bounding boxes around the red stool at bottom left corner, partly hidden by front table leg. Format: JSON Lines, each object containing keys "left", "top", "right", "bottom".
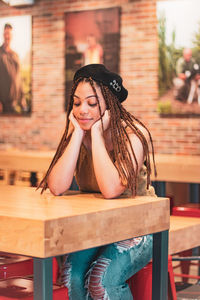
{"left": 0, "top": 278, "right": 69, "bottom": 300}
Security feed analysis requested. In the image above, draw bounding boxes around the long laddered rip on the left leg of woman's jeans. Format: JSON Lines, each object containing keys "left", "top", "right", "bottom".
{"left": 85, "top": 257, "right": 111, "bottom": 300}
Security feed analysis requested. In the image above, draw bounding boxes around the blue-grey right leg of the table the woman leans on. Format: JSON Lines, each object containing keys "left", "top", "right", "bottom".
{"left": 152, "top": 230, "right": 168, "bottom": 300}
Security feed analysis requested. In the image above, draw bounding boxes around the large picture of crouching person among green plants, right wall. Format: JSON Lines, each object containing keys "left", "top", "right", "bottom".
{"left": 157, "top": 0, "right": 200, "bottom": 117}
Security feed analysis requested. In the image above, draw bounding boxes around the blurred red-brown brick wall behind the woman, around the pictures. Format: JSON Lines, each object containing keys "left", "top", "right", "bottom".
{"left": 0, "top": 0, "right": 200, "bottom": 155}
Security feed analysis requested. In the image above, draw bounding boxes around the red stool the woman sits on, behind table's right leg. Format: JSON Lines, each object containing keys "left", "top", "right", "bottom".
{"left": 128, "top": 255, "right": 177, "bottom": 300}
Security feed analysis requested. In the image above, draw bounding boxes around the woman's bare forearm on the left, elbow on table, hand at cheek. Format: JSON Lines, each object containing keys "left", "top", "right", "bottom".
{"left": 48, "top": 113, "right": 84, "bottom": 195}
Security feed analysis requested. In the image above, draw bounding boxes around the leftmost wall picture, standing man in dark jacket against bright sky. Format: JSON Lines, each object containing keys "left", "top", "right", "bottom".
{"left": 0, "top": 15, "right": 32, "bottom": 116}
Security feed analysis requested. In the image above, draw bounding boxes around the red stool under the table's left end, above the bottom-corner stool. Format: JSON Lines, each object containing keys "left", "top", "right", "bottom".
{"left": 0, "top": 252, "right": 33, "bottom": 280}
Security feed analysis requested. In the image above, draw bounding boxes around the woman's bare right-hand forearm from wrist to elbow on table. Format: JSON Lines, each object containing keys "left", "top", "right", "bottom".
{"left": 92, "top": 131, "right": 125, "bottom": 198}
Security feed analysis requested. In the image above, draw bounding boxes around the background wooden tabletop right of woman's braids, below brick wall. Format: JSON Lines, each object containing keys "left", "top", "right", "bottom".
{"left": 151, "top": 154, "right": 200, "bottom": 183}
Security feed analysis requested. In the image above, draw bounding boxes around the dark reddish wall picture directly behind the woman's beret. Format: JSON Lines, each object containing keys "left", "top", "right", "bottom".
{"left": 65, "top": 7, "right": 120, "bottom": 109}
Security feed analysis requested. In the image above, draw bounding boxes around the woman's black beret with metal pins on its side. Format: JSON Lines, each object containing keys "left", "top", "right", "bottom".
{"left": 73, "top": 64, "right": 128, "bottom": 102}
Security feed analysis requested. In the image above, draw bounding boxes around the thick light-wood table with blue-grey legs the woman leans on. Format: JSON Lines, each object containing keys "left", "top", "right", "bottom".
{"left": 0, "top": 186, "right": 169, "bottom": 300}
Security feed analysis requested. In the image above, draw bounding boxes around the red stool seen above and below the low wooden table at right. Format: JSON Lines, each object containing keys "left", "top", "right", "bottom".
{"left": 172, "top": 203, "right": 200, "bottom": 283}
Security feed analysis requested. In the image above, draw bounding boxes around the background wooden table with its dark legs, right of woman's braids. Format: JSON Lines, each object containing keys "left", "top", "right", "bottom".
{"left": 152, "top": 154, "right": 200, "bottom": 202}
